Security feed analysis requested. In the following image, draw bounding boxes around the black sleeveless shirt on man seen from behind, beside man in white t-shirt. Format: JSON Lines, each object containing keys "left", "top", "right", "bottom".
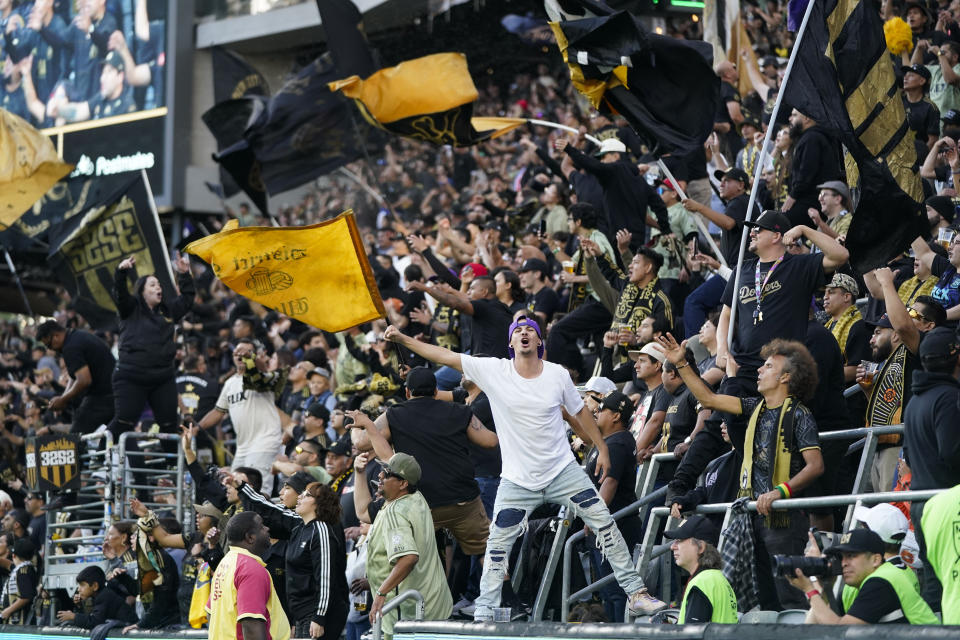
{"left": 387, "top": 398, "right": 480, "bottom": 509}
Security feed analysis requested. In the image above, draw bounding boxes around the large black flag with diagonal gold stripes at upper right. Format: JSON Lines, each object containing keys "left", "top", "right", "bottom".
{"left": 784, "top": 0, "right": 926, "bottom": 273}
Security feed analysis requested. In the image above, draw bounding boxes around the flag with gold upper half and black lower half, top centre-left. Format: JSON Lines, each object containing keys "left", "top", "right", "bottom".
{"left": 330, "top": 53, "right": 526, "bottom": 147}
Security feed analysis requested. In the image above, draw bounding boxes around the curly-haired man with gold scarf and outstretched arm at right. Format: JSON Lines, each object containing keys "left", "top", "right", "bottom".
{"left": 658, "top": 334, "right": 824, "bottom": 611}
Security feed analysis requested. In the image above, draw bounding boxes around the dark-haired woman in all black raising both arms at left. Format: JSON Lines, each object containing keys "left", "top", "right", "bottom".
{"left": 111, "top": 256, "right": 196, "bottom": 438}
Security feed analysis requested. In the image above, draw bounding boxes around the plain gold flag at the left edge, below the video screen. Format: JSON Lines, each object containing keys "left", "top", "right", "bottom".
{"left": 0, "top": 109, "right": 73, "bottom": 227}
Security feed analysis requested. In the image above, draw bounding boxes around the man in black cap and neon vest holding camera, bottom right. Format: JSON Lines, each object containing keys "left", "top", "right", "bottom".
{"left": 790, "top": 529, "right": 940, "bottom": 624}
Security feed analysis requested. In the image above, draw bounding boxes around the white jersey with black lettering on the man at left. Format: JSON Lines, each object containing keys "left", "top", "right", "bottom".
{"left": 216, "top": 373, "right": 282, "bottom": 456}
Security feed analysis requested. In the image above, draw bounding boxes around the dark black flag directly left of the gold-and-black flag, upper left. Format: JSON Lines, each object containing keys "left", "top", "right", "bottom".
{"left": 246, "top": 55, "right": 361, "bottom": 195}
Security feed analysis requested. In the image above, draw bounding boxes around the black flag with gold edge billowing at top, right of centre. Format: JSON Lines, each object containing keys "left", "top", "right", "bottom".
{"left": 545, "top": 0, "right": 720, "bottom": 155}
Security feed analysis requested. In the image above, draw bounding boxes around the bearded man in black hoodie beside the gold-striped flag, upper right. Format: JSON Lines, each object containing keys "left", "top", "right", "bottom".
{"left": 783, "top": 109, "right": 841, "bottom": 225}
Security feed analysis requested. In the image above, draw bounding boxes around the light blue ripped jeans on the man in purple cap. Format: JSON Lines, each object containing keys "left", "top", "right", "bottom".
{"left": 473, "top": 462, "right": 643, "bottom": 620}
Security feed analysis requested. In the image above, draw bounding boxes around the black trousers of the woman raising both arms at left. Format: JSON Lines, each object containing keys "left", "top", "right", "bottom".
{"left": 110, "top": 368, "right": 178, "bottom": 438}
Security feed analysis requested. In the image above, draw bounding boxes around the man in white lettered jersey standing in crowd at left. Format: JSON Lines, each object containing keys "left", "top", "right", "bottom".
{"left": 198, "top": 338, "right": 282, "bottom": 496}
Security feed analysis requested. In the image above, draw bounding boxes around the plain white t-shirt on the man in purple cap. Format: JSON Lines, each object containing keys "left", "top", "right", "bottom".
{"left": 460, "top": 355, "right": 583, "bottom": 491}
